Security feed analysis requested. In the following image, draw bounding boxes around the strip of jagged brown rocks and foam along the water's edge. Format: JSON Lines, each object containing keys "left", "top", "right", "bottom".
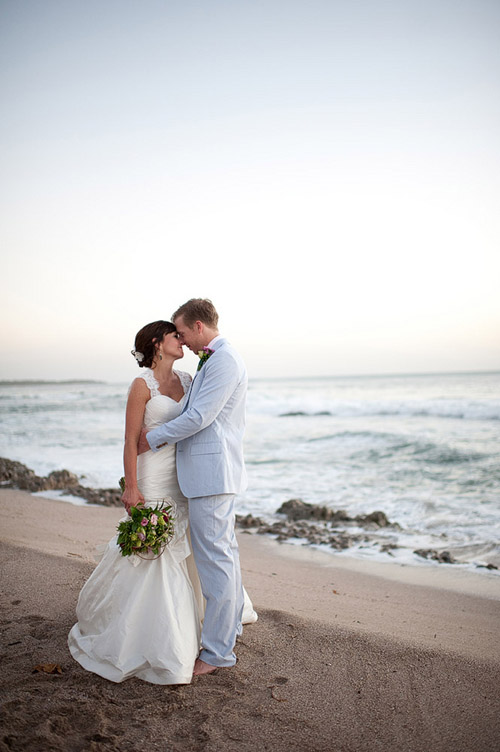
{"left": 0, "top": 457, "right": 500, "bottom": 576}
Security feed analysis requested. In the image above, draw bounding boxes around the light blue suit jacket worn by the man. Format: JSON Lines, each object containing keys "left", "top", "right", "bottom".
{"left": 146, "top": 339, "right": 248, "bottom": 499}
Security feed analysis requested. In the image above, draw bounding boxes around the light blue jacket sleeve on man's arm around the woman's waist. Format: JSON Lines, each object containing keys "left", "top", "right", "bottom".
{"left": 146, "top": 353, "right": 241, "bottom": 452}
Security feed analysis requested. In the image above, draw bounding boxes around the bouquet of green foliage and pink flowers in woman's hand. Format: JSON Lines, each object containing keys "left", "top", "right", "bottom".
{"left": 117, "top": 482, "right": 174, "bottom": 556}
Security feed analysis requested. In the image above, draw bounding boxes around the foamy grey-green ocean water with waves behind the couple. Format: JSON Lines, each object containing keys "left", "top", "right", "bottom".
{"left": 0, "top": 373, "right": 500, "bottom": 571}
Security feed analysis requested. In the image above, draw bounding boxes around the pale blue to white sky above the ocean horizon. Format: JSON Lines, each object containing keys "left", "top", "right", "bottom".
{"left": 0, "top": 0, "right": 500, "bottom": 381}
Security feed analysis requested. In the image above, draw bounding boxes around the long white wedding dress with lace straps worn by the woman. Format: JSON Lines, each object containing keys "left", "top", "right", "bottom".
{"left": 68, "top": 369, "right": 257, "bottom": 684}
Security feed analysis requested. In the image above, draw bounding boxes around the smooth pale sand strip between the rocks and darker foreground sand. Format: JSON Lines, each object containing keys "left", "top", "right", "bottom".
{"left": 0, "top": 489, "right": 500, "bottom": 662}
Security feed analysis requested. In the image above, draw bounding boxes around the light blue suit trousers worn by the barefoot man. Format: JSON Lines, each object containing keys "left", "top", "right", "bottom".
{"left": 189, "top": 494, "right": 243, "bottom": 666}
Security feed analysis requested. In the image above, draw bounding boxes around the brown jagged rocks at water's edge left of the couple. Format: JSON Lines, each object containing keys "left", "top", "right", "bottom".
{"left": 0, "top": 457, "right": 122, "bottom": 506}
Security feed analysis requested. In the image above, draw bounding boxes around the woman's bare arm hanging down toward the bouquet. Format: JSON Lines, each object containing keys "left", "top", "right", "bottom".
{"left": 122, "top": 378, "right": 150, "bottom": 512}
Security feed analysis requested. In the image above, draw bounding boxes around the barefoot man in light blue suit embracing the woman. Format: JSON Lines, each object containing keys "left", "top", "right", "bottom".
{"left": 139, "top": 298, "right": 248, "bottom": 676}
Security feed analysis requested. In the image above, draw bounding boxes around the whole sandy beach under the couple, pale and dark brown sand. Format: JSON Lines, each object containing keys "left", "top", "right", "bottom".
{"left": 0, "top": 489, "right": 500, "bottom": 752}
